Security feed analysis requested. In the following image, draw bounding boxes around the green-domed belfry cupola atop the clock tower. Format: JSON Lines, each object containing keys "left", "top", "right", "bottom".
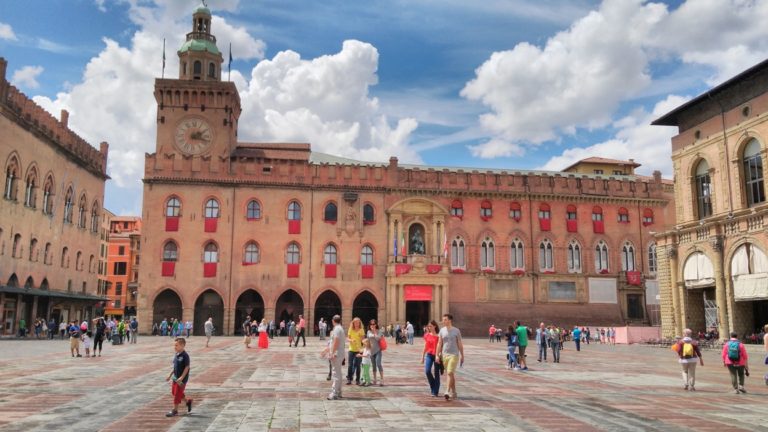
{"left": 178, "top": 5, "right": 224, "bottom": 81}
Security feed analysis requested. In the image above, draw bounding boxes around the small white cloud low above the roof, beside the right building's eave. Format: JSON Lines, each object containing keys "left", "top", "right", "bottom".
{"left": 539, "top": 95, "right": 689, "bottom": 178}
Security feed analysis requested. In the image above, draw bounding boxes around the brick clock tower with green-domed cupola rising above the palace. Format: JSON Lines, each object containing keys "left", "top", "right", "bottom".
{"left": 155, "top": 5, "right": 240, "bottom": 159}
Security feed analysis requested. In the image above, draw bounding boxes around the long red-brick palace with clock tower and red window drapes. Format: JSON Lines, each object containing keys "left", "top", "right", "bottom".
{"left": 138, "top": 7, "right": 674, "bottom": 334}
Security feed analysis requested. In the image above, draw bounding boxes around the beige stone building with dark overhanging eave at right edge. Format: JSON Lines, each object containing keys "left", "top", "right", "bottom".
{"left": 653, "top": 61, "right": 768, "bottom": 338}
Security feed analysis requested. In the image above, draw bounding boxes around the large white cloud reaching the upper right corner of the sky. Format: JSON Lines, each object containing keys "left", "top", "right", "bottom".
{"left": 461, "top": 0, "right": 768, "bottom": 157}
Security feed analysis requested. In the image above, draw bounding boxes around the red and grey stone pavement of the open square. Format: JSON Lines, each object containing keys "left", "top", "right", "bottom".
{"left": 0, "top": 336, "right": 768, "bottom": 432}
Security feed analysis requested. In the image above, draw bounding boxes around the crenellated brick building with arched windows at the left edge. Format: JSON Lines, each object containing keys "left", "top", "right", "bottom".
{"left": 0, "top": 58, "right": 108, "bottom": 334}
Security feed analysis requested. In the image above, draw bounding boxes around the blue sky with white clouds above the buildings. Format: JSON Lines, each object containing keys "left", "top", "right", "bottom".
{"left": 0, "top": 0, "right": 768, "bottom": 215}
